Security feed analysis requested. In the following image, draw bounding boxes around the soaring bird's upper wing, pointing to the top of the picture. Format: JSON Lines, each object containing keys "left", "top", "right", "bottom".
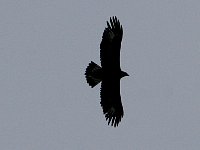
{"left": 100, "top": 17, "right": 123, "bottom": 72}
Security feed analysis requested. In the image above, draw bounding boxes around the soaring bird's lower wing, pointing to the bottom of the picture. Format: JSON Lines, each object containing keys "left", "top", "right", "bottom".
{"left": 100, "top": 78, "right": 124, "bottom": 127}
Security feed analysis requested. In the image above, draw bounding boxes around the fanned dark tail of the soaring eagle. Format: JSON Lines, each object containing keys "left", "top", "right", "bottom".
{"left": 85, "top": 61, "right": 102, "bottom": 88}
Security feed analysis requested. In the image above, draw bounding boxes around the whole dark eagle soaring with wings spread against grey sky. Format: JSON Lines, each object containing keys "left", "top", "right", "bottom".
{"left": 85, "top": 16, "right": 129, "bottom": 127}
